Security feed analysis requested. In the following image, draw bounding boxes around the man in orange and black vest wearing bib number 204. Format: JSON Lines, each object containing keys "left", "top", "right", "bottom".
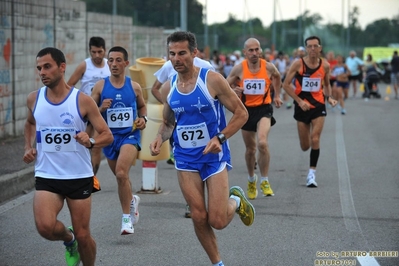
{"left": 283, "top": 36, "right": 337, "bottom": 187}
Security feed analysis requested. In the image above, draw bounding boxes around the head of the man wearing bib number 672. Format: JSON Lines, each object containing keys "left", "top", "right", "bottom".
{"left": 166, "top": 31, "right": 198, "bottom": 73}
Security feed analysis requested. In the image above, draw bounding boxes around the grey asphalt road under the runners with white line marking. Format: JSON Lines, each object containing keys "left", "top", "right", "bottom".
{"left": 0, "top": 88, "right": 399, "bottom": 266}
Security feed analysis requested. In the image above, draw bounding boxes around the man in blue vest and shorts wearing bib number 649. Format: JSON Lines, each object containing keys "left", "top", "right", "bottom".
{"left": 92, "top": 46, "right": 147, "bottom": 235}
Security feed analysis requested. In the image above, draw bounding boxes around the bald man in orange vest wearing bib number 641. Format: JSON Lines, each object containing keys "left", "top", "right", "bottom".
{"left": 227, "top": 38, "right": 282, "bottom": 199}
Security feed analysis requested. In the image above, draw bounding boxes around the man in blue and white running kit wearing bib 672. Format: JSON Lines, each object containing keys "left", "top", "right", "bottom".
{"left": 150, "top": 31, "right": 255, "bottom": 265}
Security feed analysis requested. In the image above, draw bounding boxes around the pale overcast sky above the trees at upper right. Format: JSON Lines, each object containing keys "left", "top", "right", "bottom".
{"left": 198, "top": 0, "right": 399, "bottom": 29}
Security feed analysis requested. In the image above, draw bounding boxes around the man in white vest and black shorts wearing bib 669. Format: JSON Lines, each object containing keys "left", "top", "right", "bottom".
{"left": 23, "top": 47, "right": 113, "bottom": 266}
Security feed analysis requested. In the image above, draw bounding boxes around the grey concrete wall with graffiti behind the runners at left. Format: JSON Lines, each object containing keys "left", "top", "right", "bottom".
{"left": 0, "top": 0, "right": 166, "bottom": 138}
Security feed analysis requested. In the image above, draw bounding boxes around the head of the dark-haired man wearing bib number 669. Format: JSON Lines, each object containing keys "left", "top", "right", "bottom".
{"left": 36, "top": 47, "right": 66, "bottom": 89}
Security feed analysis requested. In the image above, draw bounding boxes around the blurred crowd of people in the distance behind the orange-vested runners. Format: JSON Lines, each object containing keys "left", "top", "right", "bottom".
{"left": 206, "top": 46, "right": 399, "bottom": 115}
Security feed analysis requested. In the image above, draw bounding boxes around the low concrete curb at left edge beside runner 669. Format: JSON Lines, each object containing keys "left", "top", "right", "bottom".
{"left": 0, "top": 166, "right": 35, "bottom": 204}
